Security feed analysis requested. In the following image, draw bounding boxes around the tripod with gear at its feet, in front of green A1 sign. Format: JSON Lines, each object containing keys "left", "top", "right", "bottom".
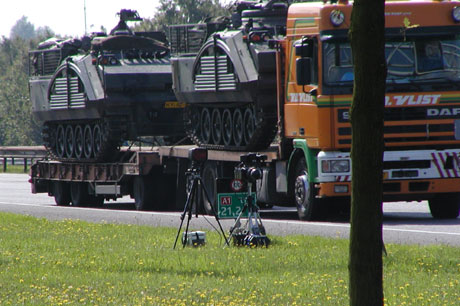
{"left": 229, "top": 182, "right": 270, "bottom": 247}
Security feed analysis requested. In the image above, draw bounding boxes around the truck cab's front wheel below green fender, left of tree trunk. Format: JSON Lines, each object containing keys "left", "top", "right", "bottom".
{"left": 294, "top": 158, "right": 321, "bottom": 221}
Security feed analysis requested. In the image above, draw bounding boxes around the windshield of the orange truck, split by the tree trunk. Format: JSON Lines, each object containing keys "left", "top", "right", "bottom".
{"left": 323, "top": 39, "right": 460, "bottom": 91}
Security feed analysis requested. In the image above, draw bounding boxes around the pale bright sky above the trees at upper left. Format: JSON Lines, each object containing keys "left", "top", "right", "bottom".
{"left": 0, "top": 0, "right": 163, "bottom": 37}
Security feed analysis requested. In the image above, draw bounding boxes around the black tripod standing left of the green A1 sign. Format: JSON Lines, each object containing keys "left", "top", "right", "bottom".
{"left": 173, "top": 164, "right": 229, "bottom": 249}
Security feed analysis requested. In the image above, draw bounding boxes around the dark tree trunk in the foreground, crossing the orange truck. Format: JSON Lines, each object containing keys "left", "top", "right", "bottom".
{"left": 348, "top": 0, "right": 386, "bottom": 306}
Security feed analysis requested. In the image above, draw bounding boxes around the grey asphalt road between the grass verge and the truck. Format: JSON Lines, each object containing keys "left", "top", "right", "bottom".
{"left": 0, "top": 174, "right": 460, "bottom": 246}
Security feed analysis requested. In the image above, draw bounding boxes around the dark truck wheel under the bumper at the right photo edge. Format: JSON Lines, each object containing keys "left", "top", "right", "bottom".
{"left": 428, "top": 193, "right": 460, "bottom": 219}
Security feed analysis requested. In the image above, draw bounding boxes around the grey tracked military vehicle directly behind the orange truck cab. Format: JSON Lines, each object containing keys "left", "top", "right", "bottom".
{"left": 168, "top": 0, "right": 289, "bottom": 151}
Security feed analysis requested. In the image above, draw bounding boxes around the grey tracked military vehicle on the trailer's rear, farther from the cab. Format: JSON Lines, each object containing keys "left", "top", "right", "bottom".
{"left": 29, "top": 10, "right": 185, "bottom": 162}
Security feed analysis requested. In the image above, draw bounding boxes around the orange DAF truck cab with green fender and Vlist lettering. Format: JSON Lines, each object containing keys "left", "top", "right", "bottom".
{"left": 277, "top": 1, "right": 460, "bottom": 220}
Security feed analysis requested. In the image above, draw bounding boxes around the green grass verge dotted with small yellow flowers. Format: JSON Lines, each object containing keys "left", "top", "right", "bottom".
{"left": 0, "top": 213, "right": 460, "bottom": 306}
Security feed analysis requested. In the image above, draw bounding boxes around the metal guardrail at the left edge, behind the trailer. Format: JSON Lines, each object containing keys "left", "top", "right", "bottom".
{"left": 0, "top": 146, "right": 46, "bottom": 173}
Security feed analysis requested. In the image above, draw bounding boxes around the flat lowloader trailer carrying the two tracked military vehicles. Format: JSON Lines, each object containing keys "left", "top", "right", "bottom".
{"left": 30, "top": 145, "right": 278, "bottom": 213}
